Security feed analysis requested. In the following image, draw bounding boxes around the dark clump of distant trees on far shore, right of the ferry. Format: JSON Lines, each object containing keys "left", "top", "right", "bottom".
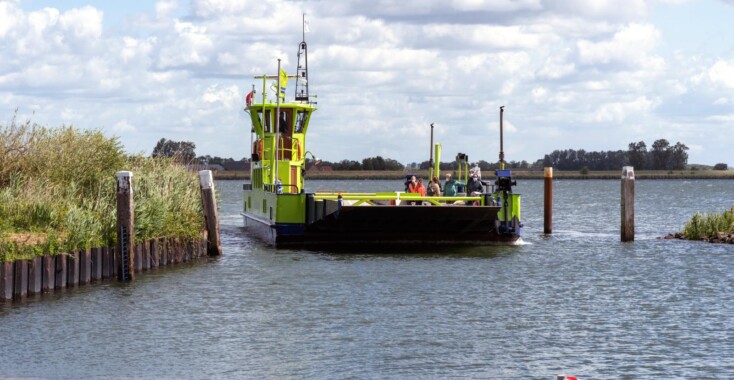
{"left": 543, "top": 139, "right": 688, "bottom": 170}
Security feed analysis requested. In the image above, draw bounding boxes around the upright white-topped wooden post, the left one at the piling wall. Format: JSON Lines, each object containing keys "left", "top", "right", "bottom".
{"left": 115, "top": 171, "right": 135, "bottom": 281}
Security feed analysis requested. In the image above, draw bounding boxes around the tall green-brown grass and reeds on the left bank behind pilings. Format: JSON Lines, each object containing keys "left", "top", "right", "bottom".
{"left": 0, "top": 118, "right": 204, "bottom": 261}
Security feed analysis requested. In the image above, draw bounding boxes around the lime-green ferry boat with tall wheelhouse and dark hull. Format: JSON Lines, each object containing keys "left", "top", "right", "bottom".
{"left": 242, "top": 33, "right": 522, "bottom": 247}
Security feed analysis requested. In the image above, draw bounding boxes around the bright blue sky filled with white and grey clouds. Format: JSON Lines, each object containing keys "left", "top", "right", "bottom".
{"left": 0, "top": 0, "right": 734, "bottom": 169}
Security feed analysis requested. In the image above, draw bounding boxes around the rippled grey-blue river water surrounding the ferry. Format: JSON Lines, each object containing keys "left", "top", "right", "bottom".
{"left": 0, "top": 180, "right": 734, "bottom": 379}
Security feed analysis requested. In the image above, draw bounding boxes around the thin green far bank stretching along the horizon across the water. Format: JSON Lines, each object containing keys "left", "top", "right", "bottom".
{"left": 214, "top": 168, "right": 734, "bottom": 180}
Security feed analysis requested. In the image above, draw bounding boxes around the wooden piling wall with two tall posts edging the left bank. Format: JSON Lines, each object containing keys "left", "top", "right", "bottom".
{"left": 0, "top": 170, "right": 222, "bottom": 301}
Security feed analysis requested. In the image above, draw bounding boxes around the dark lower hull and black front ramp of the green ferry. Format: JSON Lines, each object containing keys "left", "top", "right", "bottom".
{"left": 245, "top": 206, "right": 519, "bottom": 247}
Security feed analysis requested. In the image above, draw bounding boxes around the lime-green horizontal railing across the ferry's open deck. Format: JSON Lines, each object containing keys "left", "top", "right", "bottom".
{"left": 314, "top": 192, "right": 494, "bottom": 206}
